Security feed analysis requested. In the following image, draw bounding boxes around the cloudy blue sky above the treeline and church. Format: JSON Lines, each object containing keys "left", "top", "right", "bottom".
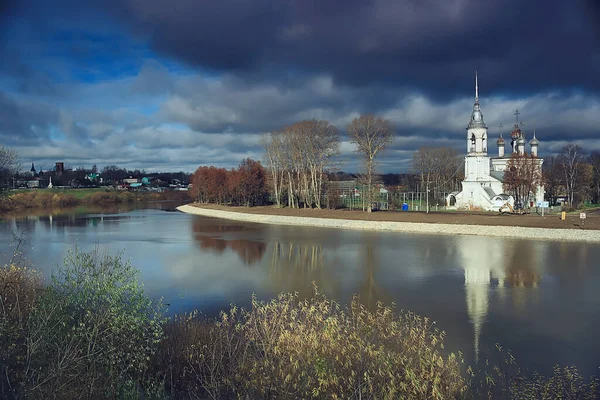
{"left": 0, "top": 0, "right": 600, "bottom": 173}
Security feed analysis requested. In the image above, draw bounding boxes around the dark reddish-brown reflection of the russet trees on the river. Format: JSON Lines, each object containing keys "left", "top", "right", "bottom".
{"left": 192, "top": 218, "right": 267, "bottom": 265}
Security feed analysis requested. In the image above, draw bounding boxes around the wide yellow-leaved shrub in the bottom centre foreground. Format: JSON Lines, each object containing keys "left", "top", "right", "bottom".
{"left": 171, "top": 293, "right": 467, "bottom": 399}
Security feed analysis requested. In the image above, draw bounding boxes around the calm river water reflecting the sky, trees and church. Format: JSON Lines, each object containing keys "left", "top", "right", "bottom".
{"left": 0, "top": 205, "right": 600, "bottom": 375}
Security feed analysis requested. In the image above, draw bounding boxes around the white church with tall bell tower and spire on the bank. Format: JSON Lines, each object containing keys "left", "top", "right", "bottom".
{"left": 446, "top": 74, "right": 544, "bottom": 211}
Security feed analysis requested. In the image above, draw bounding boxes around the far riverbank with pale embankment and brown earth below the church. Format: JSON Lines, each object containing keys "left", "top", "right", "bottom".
{"left": 177, "top": 204, "right": 600, "bottom": 243}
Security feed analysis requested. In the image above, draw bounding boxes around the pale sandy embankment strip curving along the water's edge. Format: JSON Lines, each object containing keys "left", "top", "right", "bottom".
{"left": 177, "top": 205, "right": 600, "bottom": 242}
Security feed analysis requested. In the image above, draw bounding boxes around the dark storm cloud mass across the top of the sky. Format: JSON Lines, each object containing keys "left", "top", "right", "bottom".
{"left": 92, "top": 0, "right": 600, "bottom": 96}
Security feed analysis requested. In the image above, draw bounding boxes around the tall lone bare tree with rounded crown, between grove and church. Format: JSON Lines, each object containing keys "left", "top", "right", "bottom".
{"left": 348, "top": 115, "right": 395, "bottom": 212}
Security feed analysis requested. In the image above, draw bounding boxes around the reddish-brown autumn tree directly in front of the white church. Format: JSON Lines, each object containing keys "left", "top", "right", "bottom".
{"left": 503, "top": 153, "right": 542, "bottom": 206}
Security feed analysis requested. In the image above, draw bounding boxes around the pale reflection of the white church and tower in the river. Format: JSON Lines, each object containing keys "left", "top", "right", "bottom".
{"left": 456, "top": 236, "right": 544, "bottom": 362}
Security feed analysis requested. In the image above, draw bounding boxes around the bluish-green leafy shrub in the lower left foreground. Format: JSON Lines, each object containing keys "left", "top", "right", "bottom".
{"left": 27, "top": 250, "right": 164, "bottom": 398}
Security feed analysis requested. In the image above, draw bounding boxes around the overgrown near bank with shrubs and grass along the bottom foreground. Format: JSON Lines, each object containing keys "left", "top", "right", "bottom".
{"left": 0, "top": 251, "right": 600, "bottom": 399}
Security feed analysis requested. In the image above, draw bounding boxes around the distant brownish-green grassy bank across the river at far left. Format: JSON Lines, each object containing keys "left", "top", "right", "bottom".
{"left": 0, "top": 188, "right": 189, "bottom": 213}
